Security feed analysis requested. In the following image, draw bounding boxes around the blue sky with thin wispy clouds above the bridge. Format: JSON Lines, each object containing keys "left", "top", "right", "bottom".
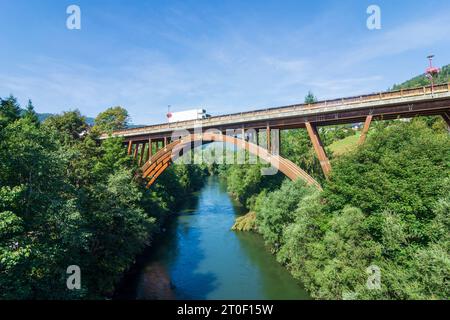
{"left": 0, "top": 0, "right": 450, "bottom": 124}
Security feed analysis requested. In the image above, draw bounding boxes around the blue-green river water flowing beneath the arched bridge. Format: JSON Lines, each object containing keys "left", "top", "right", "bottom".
{"left": 117, "top": 177, "right": 309, "bottom": 299}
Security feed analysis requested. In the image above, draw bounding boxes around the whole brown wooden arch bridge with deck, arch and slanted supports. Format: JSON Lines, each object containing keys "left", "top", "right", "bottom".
{"left": 101, "top": 83, "right": 450, "bottom": 189}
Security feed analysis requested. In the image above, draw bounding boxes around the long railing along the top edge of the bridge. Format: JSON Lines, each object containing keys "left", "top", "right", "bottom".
{"left": 108, "top": 83, "right": 450, "bottom": 136}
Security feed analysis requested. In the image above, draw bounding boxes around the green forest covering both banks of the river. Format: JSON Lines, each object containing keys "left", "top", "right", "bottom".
{"left": 0, "top": 67, "right": 450, "bottom": 299}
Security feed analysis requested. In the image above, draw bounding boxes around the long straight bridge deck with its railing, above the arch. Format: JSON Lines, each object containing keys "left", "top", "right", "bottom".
{"left": 102, "top": 83, "right": 450, "bottom": 140}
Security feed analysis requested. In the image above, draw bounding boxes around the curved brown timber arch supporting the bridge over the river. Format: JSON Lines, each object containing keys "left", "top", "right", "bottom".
{"left": 141, "top": 132, "right": 322, "bottom": 190}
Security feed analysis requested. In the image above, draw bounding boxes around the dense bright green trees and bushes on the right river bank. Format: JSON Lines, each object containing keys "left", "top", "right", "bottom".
{"left": 228, "top": 119, "right": 450, "bottom": 299}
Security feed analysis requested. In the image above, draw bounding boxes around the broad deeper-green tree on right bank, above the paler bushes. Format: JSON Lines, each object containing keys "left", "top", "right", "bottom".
{"left": 325, "top": 119, "right": 450, "bottom": 224}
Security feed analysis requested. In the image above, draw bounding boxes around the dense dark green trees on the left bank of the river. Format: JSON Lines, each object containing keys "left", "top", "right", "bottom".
{"left": 0, "top": 97, "right": 204, "bottom": 299}
